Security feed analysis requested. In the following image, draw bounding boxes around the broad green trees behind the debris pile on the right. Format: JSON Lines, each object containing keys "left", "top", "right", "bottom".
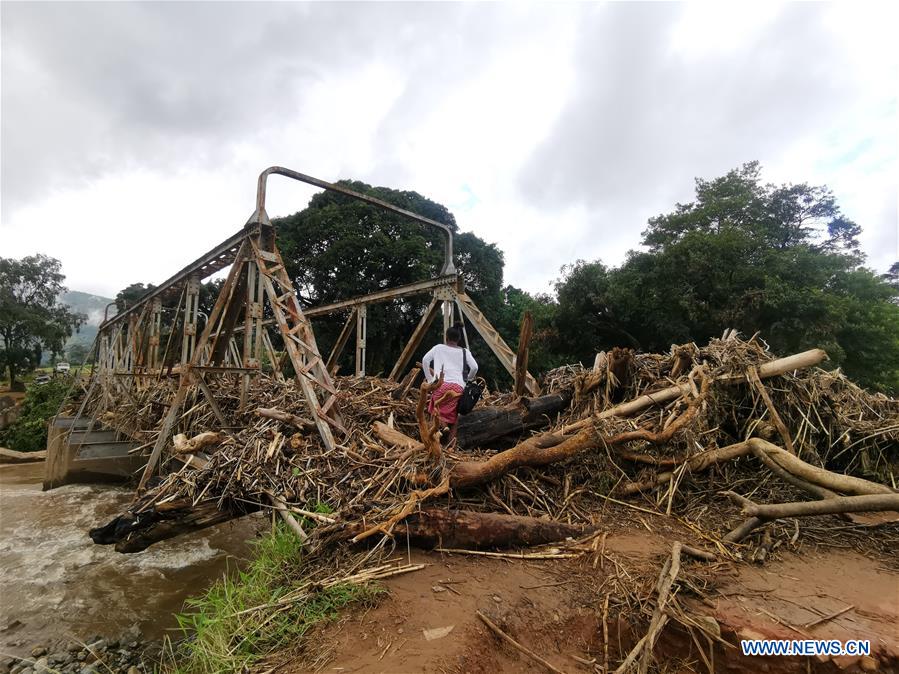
{"left": 557, "top": 162, "right": 899, "bottom": 391}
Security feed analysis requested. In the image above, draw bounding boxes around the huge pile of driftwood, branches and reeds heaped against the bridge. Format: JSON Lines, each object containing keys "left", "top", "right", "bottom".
{"left": 84, "top": 333, "right": 899, "bottom": 671}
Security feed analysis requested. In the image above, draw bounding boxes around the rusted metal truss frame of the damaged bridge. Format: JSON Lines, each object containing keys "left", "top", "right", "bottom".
{"left": 45, "top": 167, "right": 538, "bottom": 491}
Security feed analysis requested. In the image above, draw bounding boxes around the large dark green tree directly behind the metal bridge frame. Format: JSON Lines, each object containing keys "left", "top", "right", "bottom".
{"left": 274, "top": 181, "right": 503, "bottom": 375}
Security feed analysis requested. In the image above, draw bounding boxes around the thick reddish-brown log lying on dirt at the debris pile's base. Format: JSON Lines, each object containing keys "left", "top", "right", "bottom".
{"left": 356, "top": 508, "right": 585, "bottom": 549}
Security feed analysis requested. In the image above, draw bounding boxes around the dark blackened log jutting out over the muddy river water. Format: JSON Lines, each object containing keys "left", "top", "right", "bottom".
{"left": 89, "top": 501, "right": 256, "bottom": 552}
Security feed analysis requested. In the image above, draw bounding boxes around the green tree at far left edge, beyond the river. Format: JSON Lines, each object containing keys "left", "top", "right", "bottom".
{"left": 0, "top": 255, "right": 85, "bottom": 388}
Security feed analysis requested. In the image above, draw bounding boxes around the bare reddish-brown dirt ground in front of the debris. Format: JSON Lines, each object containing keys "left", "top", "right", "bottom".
{"left": 283, "top": 531, "right": 899, "bottom": 674}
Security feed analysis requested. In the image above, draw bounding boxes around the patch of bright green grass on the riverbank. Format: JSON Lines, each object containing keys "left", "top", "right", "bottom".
{"left": 170, "top": 523, "right": 382, "bottom": 674}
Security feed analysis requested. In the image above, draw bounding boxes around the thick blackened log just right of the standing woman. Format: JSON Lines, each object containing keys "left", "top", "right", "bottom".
{"left": 456, "top": 391, "right": 571, "bottom": 449}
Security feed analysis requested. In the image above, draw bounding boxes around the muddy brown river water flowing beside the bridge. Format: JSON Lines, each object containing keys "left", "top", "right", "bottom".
{"left": 0, "top": 463, "right": 266, "bottom": 655}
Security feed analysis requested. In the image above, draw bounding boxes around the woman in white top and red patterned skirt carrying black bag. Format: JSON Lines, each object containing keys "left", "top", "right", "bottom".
{"left": 421, "top": 325, "right": 478, "bottom": 441}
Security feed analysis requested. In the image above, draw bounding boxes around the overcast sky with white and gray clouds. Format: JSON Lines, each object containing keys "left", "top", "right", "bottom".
{"left": 0, "top": 2, "right": 899, "bottom": 296}
